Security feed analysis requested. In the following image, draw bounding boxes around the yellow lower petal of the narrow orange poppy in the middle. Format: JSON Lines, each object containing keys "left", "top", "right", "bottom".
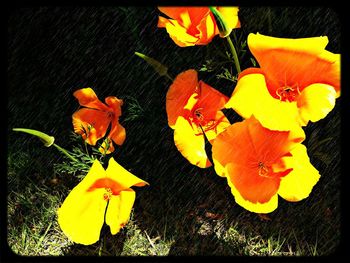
{"left": 174, "top": 116, "right": 211, "bottom": 168}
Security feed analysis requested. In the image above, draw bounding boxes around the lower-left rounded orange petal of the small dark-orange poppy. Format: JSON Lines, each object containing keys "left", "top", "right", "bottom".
{"left": 72, "top": 108, "right": 110, "bottom": 145}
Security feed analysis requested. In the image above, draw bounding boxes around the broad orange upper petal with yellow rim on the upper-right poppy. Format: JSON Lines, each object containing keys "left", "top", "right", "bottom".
{"left": 248, "top": 33, "right": 340, "bottom": 93}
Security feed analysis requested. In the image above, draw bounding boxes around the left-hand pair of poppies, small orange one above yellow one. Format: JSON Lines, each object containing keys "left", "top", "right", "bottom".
{"left": 57, "top": 88, "right": 148, "bottom": 245}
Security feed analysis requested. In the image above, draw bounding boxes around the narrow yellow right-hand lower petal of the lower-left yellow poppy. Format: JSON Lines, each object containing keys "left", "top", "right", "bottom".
{"left": 106, "top": 189, "right": 136, "bottom": 235}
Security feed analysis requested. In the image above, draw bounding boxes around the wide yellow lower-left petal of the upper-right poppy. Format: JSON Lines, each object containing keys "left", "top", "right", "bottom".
{"left": 225, "top": 74, "right": 300, "bottom": 131}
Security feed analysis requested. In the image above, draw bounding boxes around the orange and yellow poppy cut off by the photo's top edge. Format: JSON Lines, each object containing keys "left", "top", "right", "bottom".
{"left": 158, "top": 7, "right": 240, "bottom": 47}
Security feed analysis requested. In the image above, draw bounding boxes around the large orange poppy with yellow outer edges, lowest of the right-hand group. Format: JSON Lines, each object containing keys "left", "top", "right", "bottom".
{"left": 212, "top": 116, "right": 320, "bottom": 213}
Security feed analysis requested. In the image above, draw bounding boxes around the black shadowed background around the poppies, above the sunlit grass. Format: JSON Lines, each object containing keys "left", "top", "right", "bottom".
{"left": 7, "top": 6, "right": 342, "bottom": 255}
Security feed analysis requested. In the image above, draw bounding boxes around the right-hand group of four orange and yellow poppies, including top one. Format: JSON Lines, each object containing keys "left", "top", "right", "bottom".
{"left": 158, "top": 7, "right": 340, "bottom": 213}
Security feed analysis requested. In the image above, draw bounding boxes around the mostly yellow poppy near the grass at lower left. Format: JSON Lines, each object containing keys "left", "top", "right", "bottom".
{"left": 57, "top": 158, "right": 148, "bottom": 245}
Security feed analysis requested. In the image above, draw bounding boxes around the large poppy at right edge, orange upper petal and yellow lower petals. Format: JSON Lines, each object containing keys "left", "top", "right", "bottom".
{"left": 226, "top": 34, "right": 340, "bottom": 130}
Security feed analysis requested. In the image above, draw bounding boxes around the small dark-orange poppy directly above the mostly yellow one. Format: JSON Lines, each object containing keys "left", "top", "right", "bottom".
{"left": 72, "top": 88, "right": 125, "bottom": 154}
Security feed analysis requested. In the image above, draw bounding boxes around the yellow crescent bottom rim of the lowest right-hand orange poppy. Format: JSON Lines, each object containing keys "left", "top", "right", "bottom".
{"left": 226, "top": 164, "right": 278, "bottom": 214}
